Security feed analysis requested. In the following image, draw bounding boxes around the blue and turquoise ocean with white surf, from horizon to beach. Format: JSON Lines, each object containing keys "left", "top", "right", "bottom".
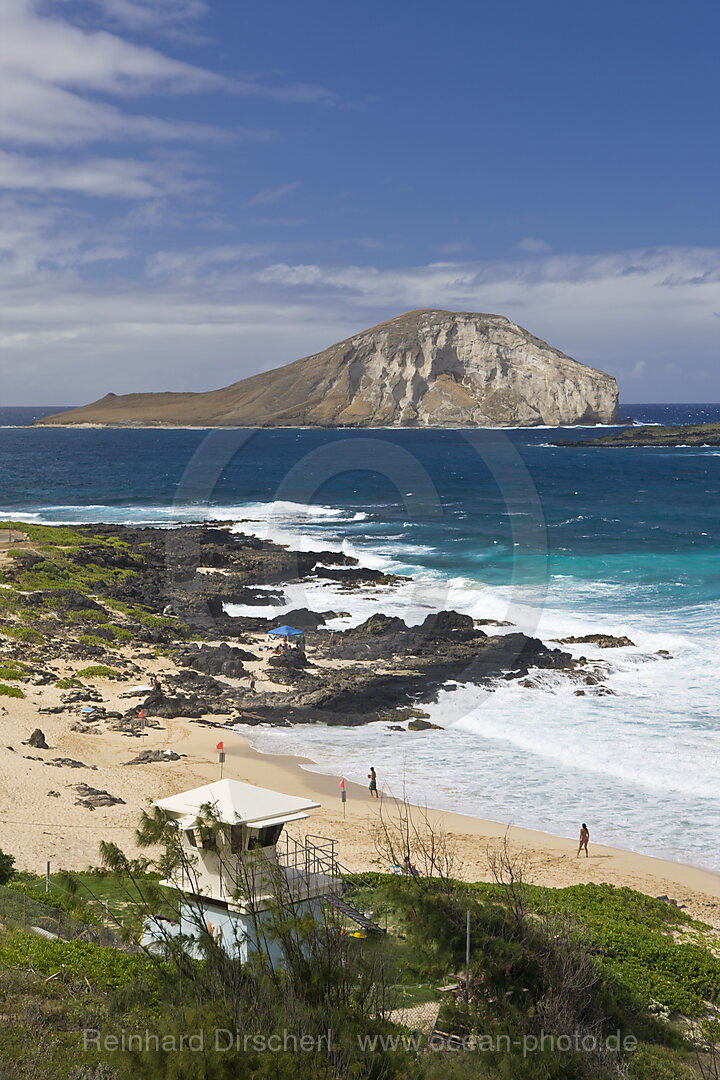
{"left": 0, "top": 404, "right": 720, "bottom": 870}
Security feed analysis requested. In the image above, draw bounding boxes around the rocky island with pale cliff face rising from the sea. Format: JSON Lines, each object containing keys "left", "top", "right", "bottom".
{"left": 39, "top": 311, "right": 617, "bottom": 428}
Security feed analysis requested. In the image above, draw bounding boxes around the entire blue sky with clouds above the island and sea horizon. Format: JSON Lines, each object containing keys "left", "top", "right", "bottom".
{"left": 0, "top": 0, "right": 720, "bottom": 404}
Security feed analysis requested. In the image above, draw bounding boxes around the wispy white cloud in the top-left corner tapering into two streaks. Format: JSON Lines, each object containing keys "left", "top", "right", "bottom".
{"left": 0, "top": 0, "right": 323, "bottom": 154}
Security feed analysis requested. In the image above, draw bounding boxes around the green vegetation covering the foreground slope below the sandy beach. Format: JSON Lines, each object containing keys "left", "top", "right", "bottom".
{"left": 0, "top": 814, "right": 720, "bottom": 1080}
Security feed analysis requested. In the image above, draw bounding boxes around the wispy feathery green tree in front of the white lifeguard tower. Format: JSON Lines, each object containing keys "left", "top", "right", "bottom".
{"left": 84, "top": 805, "right": 410, "bottom": 1080}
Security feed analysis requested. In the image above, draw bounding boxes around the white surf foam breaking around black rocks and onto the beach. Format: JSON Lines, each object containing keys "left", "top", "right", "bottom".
{"left": 1, "top": 494, "right": 720, "bottom": 869}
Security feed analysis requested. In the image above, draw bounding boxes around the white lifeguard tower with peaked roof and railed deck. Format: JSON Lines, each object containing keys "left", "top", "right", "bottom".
{"left": 142, "top": 780, "right": 341, "bottom": 963}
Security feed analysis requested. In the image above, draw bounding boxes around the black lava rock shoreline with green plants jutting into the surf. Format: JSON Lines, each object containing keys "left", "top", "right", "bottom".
{"left": 0, "top": 514, "right": 629, "bottom": 734}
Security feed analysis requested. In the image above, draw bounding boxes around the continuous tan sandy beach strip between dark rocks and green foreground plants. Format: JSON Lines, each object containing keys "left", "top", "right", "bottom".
{"left": 0, "top": 656, "right": 720, "bottom": 927}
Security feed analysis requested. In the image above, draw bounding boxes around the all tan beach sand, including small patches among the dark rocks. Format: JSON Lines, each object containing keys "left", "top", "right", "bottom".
{"left": 0, "top": 522, "right": 720, "bottom": 927}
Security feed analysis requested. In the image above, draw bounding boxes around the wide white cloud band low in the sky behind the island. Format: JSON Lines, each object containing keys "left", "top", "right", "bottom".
{"left": 0, "top": 232, "right": 720, "bottom": 403}
